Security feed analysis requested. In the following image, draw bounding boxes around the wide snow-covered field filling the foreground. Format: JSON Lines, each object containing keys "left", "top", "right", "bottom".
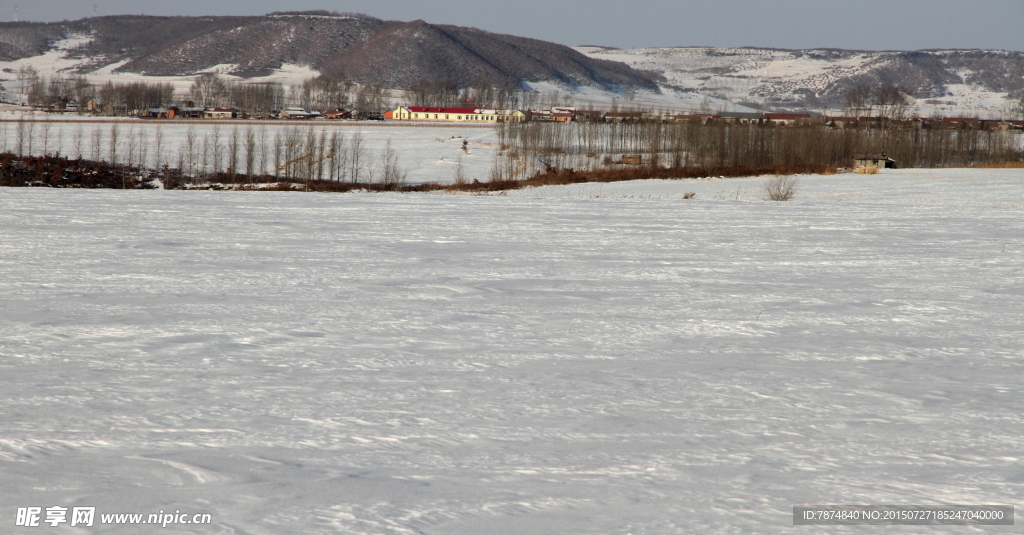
{"left": 0, "top": 169, "right": 1024, "bottom": 535}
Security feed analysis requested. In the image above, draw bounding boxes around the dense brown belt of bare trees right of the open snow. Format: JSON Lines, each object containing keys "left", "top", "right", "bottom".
{"left": 494, "top": 122, "right": 1024, "bottom": 179}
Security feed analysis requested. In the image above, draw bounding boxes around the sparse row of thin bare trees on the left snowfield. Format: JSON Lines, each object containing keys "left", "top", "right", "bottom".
{"left": 0, "top": 120, "right": 407, "bottom": 187}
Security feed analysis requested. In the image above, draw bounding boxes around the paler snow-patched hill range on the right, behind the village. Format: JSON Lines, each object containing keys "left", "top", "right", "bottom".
{"left": 577, "top": 46, "right": 1024, "bottom": 117}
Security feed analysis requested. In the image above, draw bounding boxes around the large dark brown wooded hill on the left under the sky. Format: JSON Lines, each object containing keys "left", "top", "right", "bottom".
{"left": 0, "top": 11, "right": 657, "bottom": 91}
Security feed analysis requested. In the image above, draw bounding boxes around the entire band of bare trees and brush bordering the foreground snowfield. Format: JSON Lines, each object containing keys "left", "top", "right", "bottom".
{"left": 0, "top": 121, "right": 1024, "bottom": 191}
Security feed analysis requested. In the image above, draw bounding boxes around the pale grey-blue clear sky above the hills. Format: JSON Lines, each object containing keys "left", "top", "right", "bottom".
{"left": 6, "top": 0, "right": 1024, "bottom": 51}
